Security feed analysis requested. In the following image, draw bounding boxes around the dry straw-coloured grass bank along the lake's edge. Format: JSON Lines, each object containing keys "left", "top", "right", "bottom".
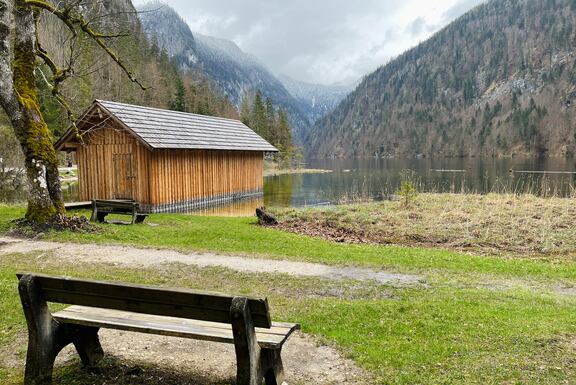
{"left": 278, "top": 194, "right": 576, "bottom": 261}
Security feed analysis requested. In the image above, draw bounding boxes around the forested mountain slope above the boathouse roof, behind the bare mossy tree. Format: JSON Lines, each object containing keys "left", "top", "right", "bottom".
{"left": 31, "top": 0, "right": 238, "bottom": 137}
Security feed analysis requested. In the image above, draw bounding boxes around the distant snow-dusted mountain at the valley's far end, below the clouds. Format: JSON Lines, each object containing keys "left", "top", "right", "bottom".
{"left": 278, "top": 75, "right": 354, "bottom": 127}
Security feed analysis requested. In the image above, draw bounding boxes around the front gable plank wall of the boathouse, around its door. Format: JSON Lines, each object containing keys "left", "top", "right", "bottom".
{"left": 77, "top": 127, "right": 150, "bottom": 201}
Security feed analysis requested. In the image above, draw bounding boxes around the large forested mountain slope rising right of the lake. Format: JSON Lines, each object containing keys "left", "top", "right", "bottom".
{"left": 306, "top": 0, "right": 576, "bottom": 157}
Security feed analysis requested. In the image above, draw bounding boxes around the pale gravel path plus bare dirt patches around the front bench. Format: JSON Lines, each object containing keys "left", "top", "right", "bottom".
{"left": 0, "top": 237, "right": 410, "bottom": 385}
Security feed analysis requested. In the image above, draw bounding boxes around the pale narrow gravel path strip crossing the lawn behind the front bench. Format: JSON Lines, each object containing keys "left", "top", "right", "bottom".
{"left": 0, "top": 237, "right": 422, "bottom": 286}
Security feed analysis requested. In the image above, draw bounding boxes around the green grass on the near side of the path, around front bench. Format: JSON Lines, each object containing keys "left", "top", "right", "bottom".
{"left": 0, "top": 254, "right": 576, "bottom": 385}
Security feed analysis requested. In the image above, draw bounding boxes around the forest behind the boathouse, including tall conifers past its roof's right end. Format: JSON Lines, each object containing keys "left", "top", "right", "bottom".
{"left": 0, "top": 1, "right": 296, "bottom": 159}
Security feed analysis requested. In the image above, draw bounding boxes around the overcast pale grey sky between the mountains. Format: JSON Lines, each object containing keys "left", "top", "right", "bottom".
{"left": 134, "top": 0, "right": 484, "bottom": 84}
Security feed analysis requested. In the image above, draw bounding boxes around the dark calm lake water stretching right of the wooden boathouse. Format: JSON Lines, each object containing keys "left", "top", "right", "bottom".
{"left": 264, "top": 158, "right": 576, "bottom": 207}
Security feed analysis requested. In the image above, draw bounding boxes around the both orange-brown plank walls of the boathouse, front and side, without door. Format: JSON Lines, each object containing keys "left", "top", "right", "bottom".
{"left": 77, "top": 123, "right": 264, "bottom": 205}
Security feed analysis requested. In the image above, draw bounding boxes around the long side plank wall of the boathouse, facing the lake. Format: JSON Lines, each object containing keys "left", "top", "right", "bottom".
{"left": 150, "top": 150, "right": 264, "bottom": 205}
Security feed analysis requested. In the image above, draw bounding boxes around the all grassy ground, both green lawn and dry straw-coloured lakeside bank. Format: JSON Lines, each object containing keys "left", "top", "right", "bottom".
{"left": 0, "top": 195, "right": 576, "bottom": 385}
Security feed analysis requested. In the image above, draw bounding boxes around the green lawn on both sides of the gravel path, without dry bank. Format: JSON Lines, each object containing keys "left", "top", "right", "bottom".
{"left": 0, "top": 202, "right": 576, "bottom": 385}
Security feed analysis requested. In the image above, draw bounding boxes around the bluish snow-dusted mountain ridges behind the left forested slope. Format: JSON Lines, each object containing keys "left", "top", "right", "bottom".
{"left": 138, "top": 1, "right": 352, "bottom": 143}
